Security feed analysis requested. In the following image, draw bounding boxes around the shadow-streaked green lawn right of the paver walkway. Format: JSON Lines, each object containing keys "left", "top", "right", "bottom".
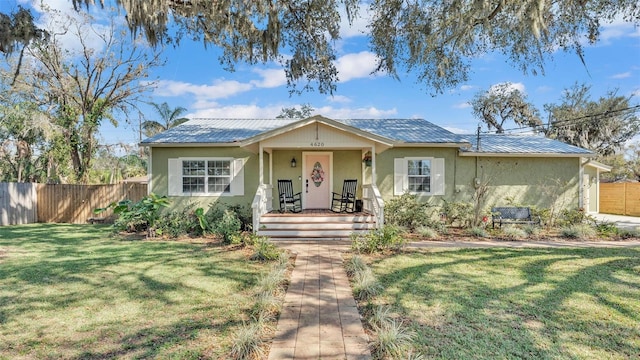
{"left": 371, "top": 248, "right": 640, "bottom": 359}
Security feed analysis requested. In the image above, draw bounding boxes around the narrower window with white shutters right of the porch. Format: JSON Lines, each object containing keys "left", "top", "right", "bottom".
{"left": 393, "top": 157, "right": 445, "bottom": 195}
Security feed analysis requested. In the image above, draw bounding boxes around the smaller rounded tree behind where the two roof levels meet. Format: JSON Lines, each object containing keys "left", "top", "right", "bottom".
{"left": 471, "top": 82, "right": 542, "bottom": 134}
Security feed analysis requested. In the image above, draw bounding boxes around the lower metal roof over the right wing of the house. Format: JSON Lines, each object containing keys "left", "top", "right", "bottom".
{"left": 460, "top": 134, "right": 595, "bottom": 157}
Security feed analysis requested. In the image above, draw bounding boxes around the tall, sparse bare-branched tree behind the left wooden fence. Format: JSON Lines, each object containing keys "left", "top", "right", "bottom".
{"left": 13, "top": 11, "right": 161, "bottom": 182}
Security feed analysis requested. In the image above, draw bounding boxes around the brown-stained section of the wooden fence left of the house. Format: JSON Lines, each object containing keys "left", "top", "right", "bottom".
{"left": 37, "top": 184, "right": 147, "bottom": 224}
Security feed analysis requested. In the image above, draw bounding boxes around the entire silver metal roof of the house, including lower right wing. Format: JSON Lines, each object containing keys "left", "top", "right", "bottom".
{"left": 141, "top": 116, "right": 594, "bottom": 156}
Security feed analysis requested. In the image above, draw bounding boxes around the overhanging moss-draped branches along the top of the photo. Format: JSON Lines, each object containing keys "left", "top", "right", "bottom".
{"left": 62, "top": 0, "right": 640, "bottom": 93}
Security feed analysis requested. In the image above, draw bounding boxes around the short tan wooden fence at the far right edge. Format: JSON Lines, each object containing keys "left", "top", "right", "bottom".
{"left": 600, "top": 183, "right": 640, "bottom": 216}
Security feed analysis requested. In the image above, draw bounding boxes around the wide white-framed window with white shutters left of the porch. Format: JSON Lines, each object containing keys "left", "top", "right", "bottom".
{"left": 169, "top": 158, "right": 244, "bottom": 196}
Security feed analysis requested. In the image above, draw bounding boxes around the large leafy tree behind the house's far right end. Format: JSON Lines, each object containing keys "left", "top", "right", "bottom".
{"left": 545, "top": 84, "right": 640, "bottom": 156}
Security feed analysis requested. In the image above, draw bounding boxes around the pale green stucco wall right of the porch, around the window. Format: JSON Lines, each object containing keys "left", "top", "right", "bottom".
{"left": 376, "top": 148, "right": 580, "bottom": 208}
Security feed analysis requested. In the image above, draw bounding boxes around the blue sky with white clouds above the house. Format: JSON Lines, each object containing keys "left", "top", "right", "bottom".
{"left": 5, "top": 0, "right": 640, "bottom": 143}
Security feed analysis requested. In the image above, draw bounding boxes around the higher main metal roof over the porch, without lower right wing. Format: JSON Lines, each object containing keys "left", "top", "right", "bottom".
{"left": 142, "top": 118, "right": 467, "bottom": 145}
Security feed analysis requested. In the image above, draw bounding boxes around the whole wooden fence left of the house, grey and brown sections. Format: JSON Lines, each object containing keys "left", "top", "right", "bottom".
{"left": 0, "top": 183, "right": 147, "bottom": 225}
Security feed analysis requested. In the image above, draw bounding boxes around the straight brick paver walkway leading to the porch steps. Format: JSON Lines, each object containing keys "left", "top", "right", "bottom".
{"left": 269, "top": 240, "right": 371, "bottom": 360}
